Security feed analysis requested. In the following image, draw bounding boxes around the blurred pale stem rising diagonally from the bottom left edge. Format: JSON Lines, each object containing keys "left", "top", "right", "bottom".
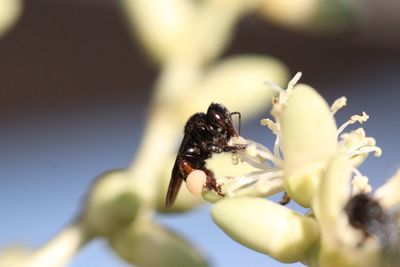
{"left": 22, "top": 220, "right": 91, "bottom": 267}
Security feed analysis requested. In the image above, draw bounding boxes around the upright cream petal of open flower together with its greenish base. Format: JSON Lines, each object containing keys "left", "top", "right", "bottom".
{"left": 280, "top": 84, "right": 337, "bottom": 207}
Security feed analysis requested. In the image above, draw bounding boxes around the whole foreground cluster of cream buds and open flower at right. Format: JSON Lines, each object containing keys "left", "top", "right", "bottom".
{"left": 195, "top": 73, "right": 400, "bottom": 267}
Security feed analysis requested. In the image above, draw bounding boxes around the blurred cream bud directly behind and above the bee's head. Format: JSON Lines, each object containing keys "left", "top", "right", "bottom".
{"left": 181, "top": 55, "right": 288, "bottom": 119}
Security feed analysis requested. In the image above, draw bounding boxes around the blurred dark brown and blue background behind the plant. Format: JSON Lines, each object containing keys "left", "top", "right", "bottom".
{"left": 0, "top": 0, "right": 400, "bottom": 267}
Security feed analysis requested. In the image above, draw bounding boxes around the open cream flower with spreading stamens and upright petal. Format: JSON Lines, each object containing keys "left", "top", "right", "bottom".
{"left": 203, "top": 73, "right": 381, "bottom": 207}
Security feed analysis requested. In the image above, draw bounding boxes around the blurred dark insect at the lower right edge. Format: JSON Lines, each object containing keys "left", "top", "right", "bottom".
{"left": 344, "top": 193, "right": 400, "bottom": 267}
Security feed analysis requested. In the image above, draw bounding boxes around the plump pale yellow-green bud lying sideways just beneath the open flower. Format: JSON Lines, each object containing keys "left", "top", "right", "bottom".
{"left": 211, "top": 197, "right": 318, "bottom": 263}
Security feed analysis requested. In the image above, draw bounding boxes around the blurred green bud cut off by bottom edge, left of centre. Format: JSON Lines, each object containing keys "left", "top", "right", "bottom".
{"left": 109, "top": 221, "right": 208, "bottom": 267}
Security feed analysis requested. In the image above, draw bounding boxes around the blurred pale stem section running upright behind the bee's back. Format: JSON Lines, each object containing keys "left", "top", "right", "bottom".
{"left": 128, "top": 65, "right": 198, "bottom": 203}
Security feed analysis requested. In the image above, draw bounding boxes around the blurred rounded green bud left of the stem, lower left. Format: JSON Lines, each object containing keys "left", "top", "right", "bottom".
{"left": 82, "top": 170, "right": 143, "bottom": 236}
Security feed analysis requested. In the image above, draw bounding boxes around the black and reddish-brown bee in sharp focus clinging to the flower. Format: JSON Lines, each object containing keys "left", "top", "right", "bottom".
{"left": 165, "top": 103, "right": 245, "bottom": 208}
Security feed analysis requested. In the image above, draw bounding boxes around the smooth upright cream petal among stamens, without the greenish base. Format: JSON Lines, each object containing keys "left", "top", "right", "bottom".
{"left": 281, "top": 84, "right": 337, "bottom": 175}
